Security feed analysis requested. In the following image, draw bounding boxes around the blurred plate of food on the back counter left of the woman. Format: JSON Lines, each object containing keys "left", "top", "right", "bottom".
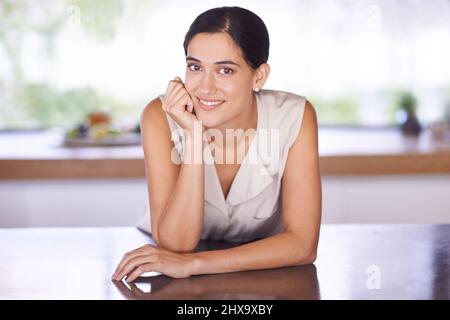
{"left": 64, "top": 111, "right": 141, "bottom": 147}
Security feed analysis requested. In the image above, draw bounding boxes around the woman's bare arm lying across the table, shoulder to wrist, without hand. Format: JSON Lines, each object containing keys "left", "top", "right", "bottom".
{"left": 191, "top": 102, "right": 322, "bottom": 274}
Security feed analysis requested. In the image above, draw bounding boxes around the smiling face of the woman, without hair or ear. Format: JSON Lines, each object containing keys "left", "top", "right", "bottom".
{"left": 185, "top": 33, "right": 255, "bottom": 128}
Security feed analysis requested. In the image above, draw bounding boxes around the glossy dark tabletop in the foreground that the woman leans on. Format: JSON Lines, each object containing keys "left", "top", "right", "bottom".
{"left": 0, "top": 224, "right": 450, "bottom": 300}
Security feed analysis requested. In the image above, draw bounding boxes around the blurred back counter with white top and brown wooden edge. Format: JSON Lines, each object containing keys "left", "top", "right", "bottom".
{"left": 0, "top": 128, "right": 450, "bottom": 180}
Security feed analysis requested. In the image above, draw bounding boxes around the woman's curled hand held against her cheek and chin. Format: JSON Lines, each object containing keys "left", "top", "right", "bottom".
{"left": 162, "top": 77, "right": 198, "bottom": 131}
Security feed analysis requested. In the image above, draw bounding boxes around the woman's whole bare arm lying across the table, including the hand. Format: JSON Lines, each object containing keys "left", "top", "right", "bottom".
{"left": 113, "top": 103, "right": 322, "bottom": 281}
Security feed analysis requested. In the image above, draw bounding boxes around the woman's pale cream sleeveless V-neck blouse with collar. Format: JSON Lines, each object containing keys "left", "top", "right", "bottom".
{"left": 138, "top": 90, "right": 306, "bottom": 241}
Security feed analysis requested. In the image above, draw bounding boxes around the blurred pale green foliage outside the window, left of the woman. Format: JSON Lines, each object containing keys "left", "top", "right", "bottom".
{"left": 0, "top": 0, "right": 131, "bottom": 129}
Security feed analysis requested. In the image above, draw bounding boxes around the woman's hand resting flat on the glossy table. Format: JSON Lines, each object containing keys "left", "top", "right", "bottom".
{"left": 112, "top": 244, "right": 193, "bottom": 282}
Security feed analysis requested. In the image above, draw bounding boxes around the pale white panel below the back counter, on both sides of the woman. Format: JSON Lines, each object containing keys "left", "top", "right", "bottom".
{"left": 0, "top": 175, "right": 450, "bottom": 227}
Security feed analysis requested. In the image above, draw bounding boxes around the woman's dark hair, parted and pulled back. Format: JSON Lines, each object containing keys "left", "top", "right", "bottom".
{"left": 183, "top": 7, "right": 269, "bottom": 69}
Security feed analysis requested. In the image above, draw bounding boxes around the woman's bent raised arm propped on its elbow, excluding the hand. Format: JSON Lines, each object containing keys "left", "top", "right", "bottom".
{"left": 141, "top": 99, "right": 204, "bottom": 252}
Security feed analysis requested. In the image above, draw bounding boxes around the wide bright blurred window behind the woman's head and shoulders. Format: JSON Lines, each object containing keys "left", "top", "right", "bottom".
{"left": 0, "top": 0, "right": 450, "bottom": 129}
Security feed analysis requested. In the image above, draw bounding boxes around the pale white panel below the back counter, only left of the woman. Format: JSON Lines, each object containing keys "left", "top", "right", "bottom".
{"left": 0, "top": 179, "right": 147, "bottom": 227}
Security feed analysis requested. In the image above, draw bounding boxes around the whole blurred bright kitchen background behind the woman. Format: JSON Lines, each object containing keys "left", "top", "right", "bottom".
{"left": 0, "top": 0, "right": 450, "bottom": 227}
